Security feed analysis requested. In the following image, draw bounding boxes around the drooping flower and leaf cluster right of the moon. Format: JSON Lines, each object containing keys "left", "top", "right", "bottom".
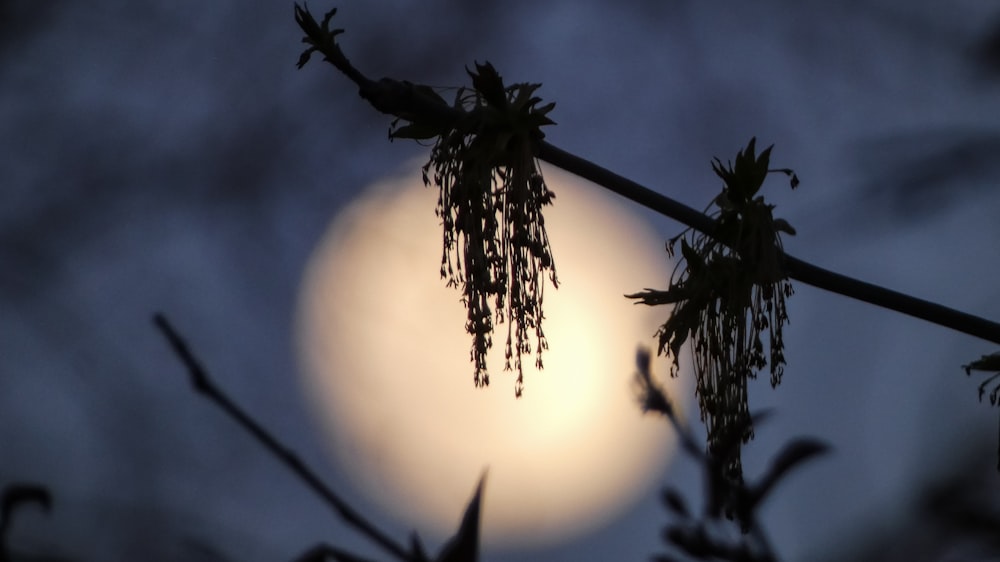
{"left": 626, "top": 139, "right": 798, "bottom": 482}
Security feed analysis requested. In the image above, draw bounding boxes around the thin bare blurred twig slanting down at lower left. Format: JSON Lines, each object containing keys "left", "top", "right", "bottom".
{"left": 153, "top": 313, "right": 412, "bottom": 560}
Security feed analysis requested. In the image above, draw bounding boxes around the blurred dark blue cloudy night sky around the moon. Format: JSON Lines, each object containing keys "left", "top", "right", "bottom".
{"left": 0, "top": 0, "right": 1000, "bottom": 561}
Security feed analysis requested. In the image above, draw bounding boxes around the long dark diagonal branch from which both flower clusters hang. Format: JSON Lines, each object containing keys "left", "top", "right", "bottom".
{"left": 295, "top": 5, "right": 1000, "bottom": 344}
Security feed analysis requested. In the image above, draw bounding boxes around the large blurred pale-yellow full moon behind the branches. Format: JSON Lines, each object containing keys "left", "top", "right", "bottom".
{"left": 298, "top": 166, "right": 683, "bottom": 546}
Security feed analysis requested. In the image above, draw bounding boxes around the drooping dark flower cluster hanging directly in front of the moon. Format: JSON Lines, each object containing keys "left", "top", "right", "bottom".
{"left": 390, "top": 63, "right": 558, "bottom": 396}
